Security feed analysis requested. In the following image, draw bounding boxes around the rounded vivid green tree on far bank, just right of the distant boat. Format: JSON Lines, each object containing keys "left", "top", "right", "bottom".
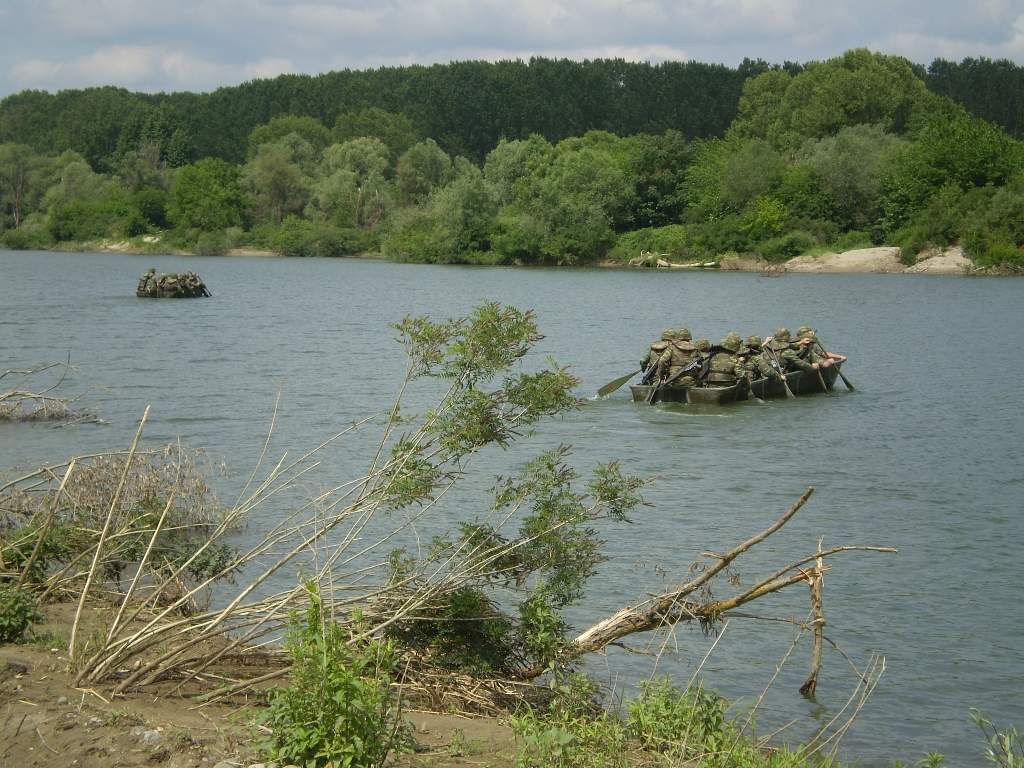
{"left": 171, "top": 158, "right": 251, "bottom": 231}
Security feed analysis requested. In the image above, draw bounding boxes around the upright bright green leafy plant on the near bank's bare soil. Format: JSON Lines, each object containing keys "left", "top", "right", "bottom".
{"left": 257, "top": 583, "right": 400, "bottom": 768}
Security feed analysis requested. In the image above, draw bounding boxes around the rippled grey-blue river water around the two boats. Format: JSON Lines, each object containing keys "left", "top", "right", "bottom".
{"left": 0, "top": 251, "right": 1024, "bottom": 765}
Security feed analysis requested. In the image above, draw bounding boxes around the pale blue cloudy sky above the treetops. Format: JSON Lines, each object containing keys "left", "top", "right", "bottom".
{"left": 0, "top": 0, "right": 1024, "bottom": 96}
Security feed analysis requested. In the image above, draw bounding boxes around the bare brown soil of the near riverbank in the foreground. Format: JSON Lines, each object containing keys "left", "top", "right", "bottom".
{"left": 0, "top": 603, "right": 515, "bottom": 768}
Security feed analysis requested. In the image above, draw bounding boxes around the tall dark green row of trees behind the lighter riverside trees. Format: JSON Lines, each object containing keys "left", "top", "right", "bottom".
{"left": 0, "top": 57, "right": 1024, "bottom": 172}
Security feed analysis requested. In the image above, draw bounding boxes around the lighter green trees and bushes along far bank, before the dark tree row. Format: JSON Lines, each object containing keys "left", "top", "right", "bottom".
{"left": 0, "top": 49, "right": 1024, "bottom": 270}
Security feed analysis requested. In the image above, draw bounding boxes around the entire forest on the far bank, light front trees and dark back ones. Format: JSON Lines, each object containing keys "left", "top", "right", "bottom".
{"left": 0, "top": 49, "right": 1024, "bottom": 264}
